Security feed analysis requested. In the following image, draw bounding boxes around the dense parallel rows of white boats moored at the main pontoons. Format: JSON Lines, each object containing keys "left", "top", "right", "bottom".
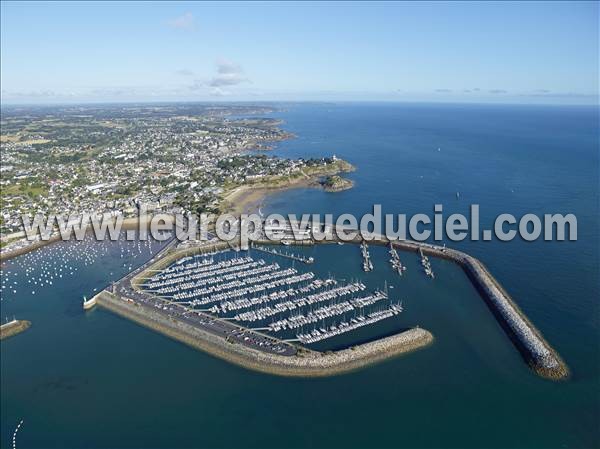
{"left": 140, "top": 247, "right": 402, "bottom": 344}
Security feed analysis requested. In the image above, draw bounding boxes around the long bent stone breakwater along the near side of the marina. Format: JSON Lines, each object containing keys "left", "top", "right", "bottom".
{"left": 96, "top": 291, "right": 433, "bottom": 377}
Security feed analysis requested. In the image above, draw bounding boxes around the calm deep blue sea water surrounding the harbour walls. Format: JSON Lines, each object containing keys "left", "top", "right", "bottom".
{"left": 0, "top": 104, "right": 600, "bottom": 447}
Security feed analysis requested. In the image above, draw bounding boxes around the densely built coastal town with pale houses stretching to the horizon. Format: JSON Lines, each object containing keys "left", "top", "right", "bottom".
{"left": 0, "top": 104, "right": 352, "bottom": 249}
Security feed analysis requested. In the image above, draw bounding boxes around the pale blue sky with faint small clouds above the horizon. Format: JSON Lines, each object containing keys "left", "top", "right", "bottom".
{"left": 0, "top": 1, "right": 599, "bottom": 104}
